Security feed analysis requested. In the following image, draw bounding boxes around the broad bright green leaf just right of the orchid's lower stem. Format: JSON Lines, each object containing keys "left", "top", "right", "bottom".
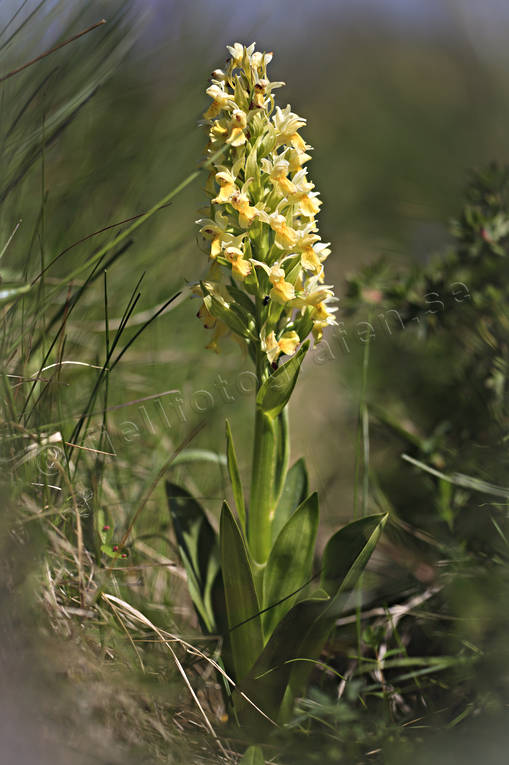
{"left": 263, "top": 492, "right": 319, "bottom": 638}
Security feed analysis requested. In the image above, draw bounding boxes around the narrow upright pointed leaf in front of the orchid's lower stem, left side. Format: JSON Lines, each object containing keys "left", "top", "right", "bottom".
{"left": 219, "top": 502, "right": 263, "bottom": 682}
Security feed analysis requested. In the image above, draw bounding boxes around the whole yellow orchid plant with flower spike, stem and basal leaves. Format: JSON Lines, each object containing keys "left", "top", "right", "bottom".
{"left": 168, "top": 43, "right": 385, "bottom": 740}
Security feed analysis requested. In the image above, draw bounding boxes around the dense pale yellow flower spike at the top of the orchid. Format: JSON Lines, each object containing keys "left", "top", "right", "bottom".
{"left": 197, "top": 43, "right": 336, "bottom": 358}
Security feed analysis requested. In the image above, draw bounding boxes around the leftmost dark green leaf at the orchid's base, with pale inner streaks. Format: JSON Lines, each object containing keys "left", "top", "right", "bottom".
{"left": 166, "top": 481, "right": 219, "bottom": 632}
